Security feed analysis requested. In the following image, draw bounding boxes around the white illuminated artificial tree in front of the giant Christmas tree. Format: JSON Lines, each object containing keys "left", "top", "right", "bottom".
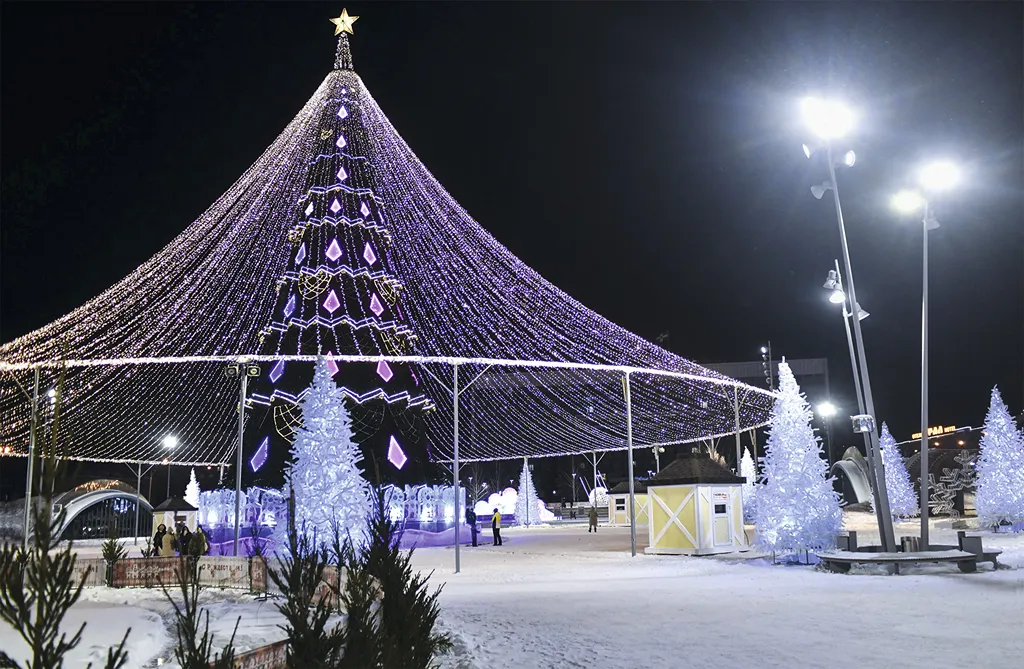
{"left": 285, "top": 358, "right": 371, "bottom": 544}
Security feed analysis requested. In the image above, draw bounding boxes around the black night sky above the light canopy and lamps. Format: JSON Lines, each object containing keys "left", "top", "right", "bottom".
{"left": 0, "top": 2, "right": 1024, "bottom": 487}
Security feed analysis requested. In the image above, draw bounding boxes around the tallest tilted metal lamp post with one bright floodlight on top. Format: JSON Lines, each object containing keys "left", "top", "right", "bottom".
{"left": 803, "top": 98, "right": 896, "bottom": 552}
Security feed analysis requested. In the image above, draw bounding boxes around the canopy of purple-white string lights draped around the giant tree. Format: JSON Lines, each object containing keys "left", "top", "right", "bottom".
{"left": 0, "top": 27, "right": 772, "bottom": 464}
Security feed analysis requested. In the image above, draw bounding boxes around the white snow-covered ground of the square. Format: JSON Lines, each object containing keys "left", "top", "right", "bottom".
{"left": 0, "top": 513, "right": 1024, "bottom": 669}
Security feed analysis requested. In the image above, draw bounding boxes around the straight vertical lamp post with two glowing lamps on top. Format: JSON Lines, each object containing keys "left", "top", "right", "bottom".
{"left": 893, "top": 162, "right": 958, "bottom": 550}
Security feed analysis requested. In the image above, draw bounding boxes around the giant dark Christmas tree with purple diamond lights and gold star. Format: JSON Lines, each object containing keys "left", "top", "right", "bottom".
{"left": 247, "top": 11, "right": 431, "bottom": 485}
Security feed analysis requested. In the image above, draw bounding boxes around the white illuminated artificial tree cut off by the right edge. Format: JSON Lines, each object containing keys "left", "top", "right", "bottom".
{"left": 975, "top": 387, "right": 1024, "bottom": 528}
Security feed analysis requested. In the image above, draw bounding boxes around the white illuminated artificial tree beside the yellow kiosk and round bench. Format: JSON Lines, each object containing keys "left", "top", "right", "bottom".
{"left": 754, "top": 359, "right": 843, "bottom": 553}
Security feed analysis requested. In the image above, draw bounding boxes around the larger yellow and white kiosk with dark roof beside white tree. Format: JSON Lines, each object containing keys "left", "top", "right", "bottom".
{"left": 638, "top": 453, "right": 750, "bottom": 555}
